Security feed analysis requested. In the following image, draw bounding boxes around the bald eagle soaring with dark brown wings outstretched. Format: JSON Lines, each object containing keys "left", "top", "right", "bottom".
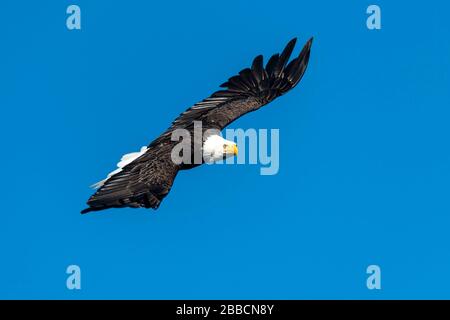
{"left": 81, "top": 38, "right": 312, "bottom": 213}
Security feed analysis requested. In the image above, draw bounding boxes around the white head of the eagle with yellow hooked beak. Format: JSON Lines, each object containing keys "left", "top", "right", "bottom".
{"left": 203, "top": 134, "right": 238, "bottom": 163}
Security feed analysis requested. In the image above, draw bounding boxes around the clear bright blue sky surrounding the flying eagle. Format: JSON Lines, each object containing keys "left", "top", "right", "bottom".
{"left": 0, "top": 0, "right": 450, "bottom": 299}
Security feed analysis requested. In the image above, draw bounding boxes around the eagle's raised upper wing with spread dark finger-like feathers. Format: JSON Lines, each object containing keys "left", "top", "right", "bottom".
{"left": 150, "top": 38, "right": 313, "bottom": 146}
